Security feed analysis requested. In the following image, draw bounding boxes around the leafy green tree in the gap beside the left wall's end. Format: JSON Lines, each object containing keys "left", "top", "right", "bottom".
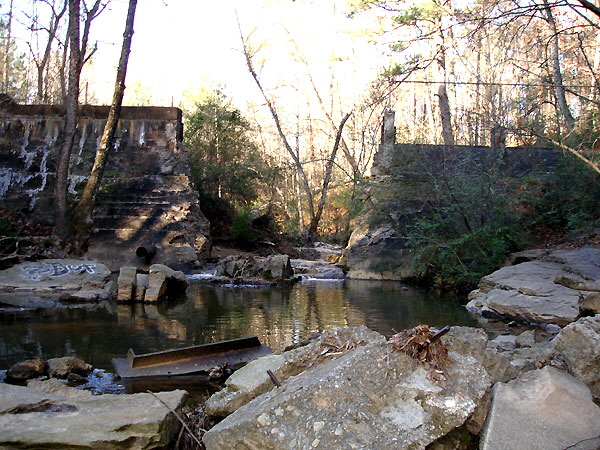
{"left": 184, "top": 90, "right": 281, "bottom": 242}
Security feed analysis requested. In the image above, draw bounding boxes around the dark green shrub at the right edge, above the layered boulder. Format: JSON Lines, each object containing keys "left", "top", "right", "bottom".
{"left": 528, "top": 155, "right": 600, "bottom": 233}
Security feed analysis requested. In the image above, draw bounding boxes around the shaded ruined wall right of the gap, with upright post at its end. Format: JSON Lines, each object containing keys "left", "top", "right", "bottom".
{"left": 343, "top": 112, "right": 563, "bottom": 280}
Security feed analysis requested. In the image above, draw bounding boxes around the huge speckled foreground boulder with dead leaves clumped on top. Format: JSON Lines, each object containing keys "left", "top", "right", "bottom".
{"left": 204, "top": 342, "right": 490, "bottom": 450}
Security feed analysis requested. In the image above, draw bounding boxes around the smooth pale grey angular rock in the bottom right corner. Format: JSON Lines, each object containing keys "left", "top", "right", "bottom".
{"left": 480, "top": 367, "right": 600, "bottom": 450}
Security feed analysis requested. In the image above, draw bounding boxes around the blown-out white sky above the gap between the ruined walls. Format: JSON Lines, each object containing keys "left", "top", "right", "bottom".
{"left": 67, "top": 0, "right": 384, "bottom": 110}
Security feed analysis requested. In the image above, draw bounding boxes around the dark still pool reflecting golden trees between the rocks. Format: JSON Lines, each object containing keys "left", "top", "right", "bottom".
{"left": 0, "top": 281, "right": 477, "bottom": 371}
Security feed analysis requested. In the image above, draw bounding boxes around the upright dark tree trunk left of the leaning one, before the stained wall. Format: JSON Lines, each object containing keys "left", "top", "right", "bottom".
{"left": 54, "top": 0, "right": 81, "bottom": 239}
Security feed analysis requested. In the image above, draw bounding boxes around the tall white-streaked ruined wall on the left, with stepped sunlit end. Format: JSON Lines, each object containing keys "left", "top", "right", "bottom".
{"left": 0, "top": 104, "right": 210, "bottom": 269}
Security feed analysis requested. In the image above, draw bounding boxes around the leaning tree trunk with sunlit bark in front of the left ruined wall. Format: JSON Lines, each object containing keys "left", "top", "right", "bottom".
{"left": 71, "top": 0, "right": 137, "bottom": 251}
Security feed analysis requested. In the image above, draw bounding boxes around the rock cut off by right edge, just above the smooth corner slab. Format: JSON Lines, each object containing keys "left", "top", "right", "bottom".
{"left": 552, "top": 315, "right": 600, "bottom": 398}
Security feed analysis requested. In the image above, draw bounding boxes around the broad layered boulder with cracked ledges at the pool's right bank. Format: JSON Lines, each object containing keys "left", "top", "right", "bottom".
{"left": 467, "top": 249, "right": 600, "bottom": 326}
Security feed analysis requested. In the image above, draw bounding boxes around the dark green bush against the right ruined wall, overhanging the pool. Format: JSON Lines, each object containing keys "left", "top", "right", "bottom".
{"left": 408, "top": 152, "right": 525, "bottom": 290}
